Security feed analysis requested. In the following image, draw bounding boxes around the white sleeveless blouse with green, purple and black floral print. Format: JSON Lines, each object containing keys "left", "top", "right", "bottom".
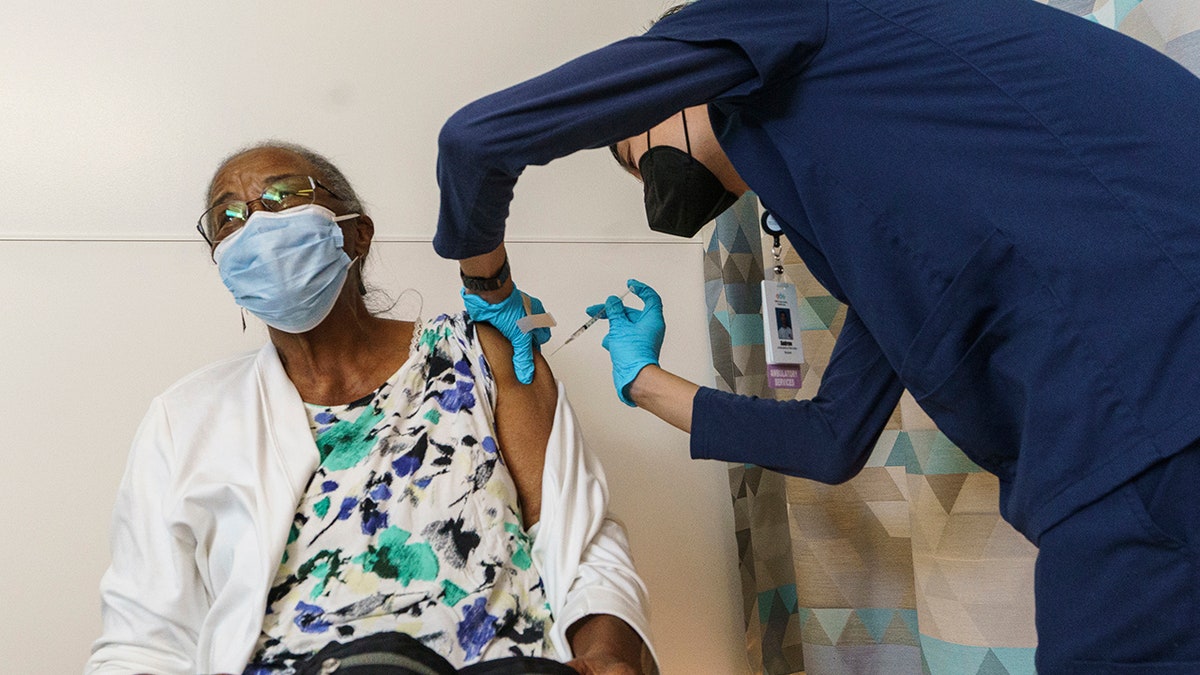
{"left": 245, "top": 315, "right": 554, "bottom": 675}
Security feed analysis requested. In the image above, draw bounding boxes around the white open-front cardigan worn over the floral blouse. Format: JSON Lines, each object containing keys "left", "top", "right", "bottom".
{"left": 84, "top": 344, "right": 653, "bottom": 675}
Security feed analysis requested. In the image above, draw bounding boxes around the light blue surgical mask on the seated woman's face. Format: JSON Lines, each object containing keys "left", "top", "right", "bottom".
{"left": 212, "top": 204, "right": 359, "bottom": 333}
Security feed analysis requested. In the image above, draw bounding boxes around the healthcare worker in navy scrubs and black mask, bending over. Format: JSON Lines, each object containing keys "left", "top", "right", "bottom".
{"left": 434, "top": 0, "right": 1200, "bottom": 674}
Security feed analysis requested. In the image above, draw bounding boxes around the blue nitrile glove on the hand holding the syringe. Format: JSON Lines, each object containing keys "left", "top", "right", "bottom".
{"left": 587, "top": 279, "right": 667, "bottom": 407}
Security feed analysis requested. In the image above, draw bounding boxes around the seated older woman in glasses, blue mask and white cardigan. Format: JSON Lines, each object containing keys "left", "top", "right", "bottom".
{"left": 86, "top": 143, "right": 653, "bottom": 675}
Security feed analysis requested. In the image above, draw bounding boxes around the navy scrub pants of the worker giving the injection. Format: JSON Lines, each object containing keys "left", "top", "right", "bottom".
{"left": 1034, "top": 442, "right": 1200, "bottom": 675}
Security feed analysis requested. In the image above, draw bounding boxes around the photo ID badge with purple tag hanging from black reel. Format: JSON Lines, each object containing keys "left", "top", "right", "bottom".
{"left": 762, "top": 211, "right": 804, "bottom": 389}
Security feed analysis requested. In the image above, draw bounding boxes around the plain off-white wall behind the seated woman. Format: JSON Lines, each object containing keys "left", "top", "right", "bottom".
{"left": 0, "top": 0, "right": 746, "bottom": 674}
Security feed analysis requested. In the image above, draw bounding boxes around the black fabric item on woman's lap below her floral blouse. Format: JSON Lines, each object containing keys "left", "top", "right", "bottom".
{"left": 296, "top": 633, "right": 578, "bottom": 675}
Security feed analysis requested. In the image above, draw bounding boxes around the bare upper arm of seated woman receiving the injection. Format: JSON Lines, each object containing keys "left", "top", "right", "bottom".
{"left": 475, "top": 323, "right": 558, "bottom": 528}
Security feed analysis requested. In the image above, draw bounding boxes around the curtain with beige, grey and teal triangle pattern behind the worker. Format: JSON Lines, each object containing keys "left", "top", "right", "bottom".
{"left": 704, "top": 5, "right": 1200, "bottom": 675}
